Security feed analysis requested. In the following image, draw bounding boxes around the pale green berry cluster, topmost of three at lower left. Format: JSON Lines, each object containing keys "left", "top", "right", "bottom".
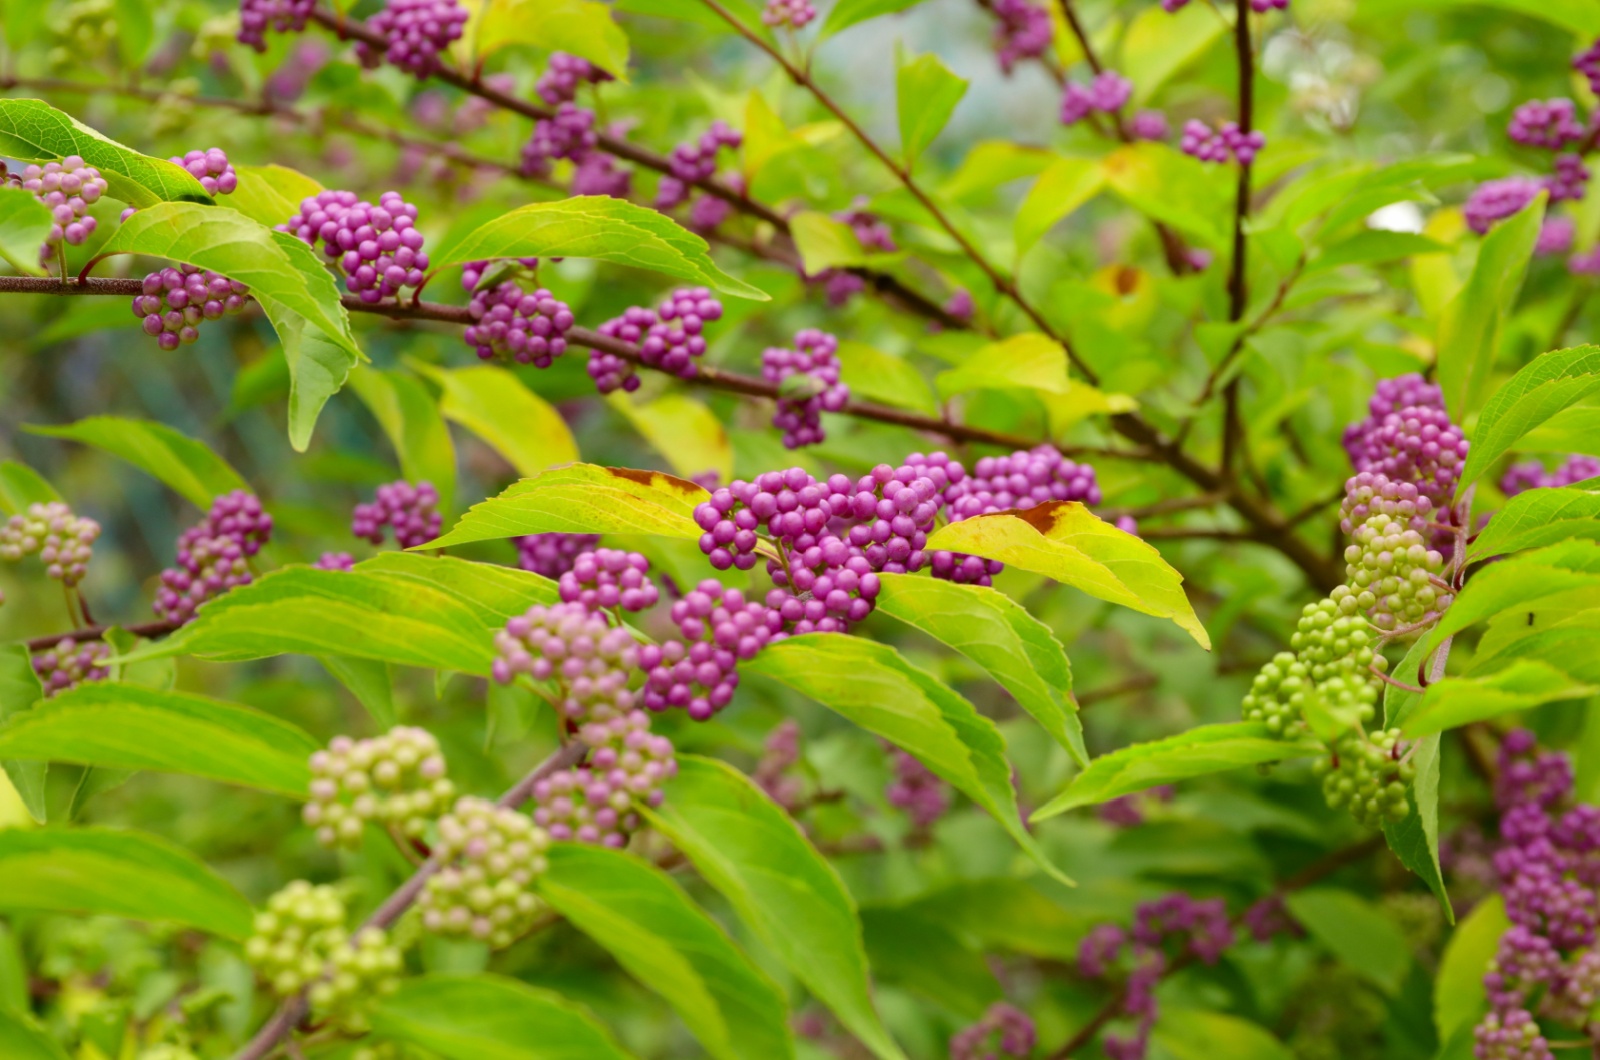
{"left": 302, "top": 725, "right": 456, "bottom": 847}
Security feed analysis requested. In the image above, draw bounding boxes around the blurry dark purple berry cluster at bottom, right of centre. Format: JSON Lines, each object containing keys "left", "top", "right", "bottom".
{"left": 1078, "top": 893, "right": 1235, "bottom": 1060}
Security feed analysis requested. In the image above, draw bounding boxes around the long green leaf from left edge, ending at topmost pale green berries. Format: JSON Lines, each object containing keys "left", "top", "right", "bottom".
{"left": 0, "top": 682, "right": 318, "bottom": 797}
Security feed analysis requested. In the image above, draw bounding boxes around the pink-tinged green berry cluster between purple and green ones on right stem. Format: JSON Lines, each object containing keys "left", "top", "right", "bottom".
{"left": 1344, "top": 512, "right": 1451, "bottom": 629}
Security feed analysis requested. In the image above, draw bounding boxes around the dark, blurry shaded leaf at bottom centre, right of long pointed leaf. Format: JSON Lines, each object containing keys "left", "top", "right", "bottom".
{"left": 861, "top": 908, "right": 1003, "bottom": 1023}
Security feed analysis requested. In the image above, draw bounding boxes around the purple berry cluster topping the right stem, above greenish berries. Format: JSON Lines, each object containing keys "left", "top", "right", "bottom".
{"left": 1344, "top": 373, "right": 1469, "bottom": 509}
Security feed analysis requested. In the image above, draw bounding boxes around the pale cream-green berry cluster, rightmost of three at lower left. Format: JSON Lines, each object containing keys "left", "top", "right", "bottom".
{"left": 418, "top": 796, "right": 550, "bottom": 950}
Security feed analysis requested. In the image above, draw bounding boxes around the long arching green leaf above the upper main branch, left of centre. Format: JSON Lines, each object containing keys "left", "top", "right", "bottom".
{"left": 430, "top": 195, "right": 768, "bottom": 301}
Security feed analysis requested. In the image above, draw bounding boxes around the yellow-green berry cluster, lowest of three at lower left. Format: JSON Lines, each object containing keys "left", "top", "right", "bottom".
{"left": 245, "top": 879, "right": 403, "bottom": 1030}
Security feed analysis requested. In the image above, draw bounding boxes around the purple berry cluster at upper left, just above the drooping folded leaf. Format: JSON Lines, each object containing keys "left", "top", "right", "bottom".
{"left": 278, "top": 191, "right": 427, "bottom": 304}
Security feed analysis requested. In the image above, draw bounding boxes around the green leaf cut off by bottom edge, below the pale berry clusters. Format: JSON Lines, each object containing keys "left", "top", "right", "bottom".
{"left": 373, "top": 974, "right": 629, "bottom": 1060}
